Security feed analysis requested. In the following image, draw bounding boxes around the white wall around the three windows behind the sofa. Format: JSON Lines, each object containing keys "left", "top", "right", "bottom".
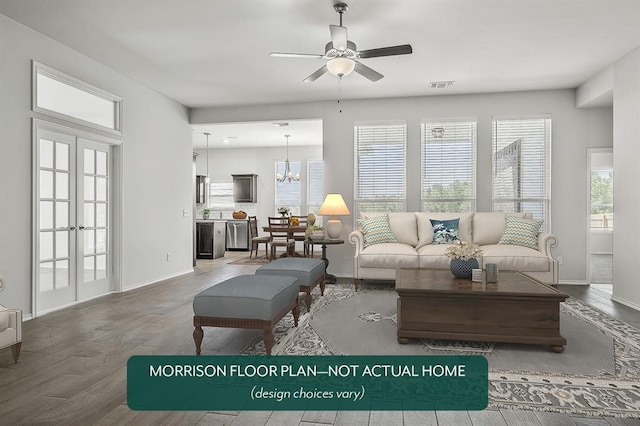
{"left": 190, "top": 90, "right": 611, "bottom": 283}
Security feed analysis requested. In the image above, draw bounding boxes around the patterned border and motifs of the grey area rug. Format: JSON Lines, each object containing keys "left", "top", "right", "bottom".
{"left": 242, "top": 284, "right": 640, "bottom": 418}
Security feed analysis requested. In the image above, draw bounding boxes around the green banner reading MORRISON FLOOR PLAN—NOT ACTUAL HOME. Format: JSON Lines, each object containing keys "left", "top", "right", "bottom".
{"left": 127, "top": 355, "right": 488, "bottom": 411}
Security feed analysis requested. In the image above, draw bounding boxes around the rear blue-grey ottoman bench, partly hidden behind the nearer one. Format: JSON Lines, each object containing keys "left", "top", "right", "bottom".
{"left": 256, "top": 257, "right": 325, "bottom": 312}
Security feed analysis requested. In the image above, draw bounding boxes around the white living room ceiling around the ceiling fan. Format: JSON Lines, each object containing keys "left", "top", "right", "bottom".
{"left": 0, "top": 0, "right": 640, "bottom": 146}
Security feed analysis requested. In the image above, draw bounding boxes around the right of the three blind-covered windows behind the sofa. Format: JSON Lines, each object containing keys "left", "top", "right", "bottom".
{"left": 492, "top": 115, "right": 551, "bottom": 230}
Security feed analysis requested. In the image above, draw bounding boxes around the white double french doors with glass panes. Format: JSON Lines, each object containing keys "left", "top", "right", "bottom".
{"left": 34, "top": 127, "right": 112, "bottom": 314}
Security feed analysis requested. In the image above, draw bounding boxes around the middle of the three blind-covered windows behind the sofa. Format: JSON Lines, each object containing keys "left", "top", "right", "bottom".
{"left": 421, "top": 120, "right": 477, "bottom": 212}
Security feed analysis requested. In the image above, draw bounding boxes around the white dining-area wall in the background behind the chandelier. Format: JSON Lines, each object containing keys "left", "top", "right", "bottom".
{"left": 195, "top": 144, "right": 322, "bottom": 226}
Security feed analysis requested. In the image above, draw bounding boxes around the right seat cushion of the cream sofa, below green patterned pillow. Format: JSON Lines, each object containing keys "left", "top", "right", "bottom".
{"left": 482, "top": 244, "right": 549, "bottom": 272}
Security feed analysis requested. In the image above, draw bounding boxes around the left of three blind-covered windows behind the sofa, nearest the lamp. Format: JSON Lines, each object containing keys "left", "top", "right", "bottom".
{"left": 354, "top": 122, "right": 407, "bottom": 219}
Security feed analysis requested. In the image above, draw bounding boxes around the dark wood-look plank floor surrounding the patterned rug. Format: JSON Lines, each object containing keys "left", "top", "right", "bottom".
{"left": 0, "top": 252, "right": 640, "bottom": 426}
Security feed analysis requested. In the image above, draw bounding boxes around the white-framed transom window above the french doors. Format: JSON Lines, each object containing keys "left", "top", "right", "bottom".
{"left": 33, "top": 61, "right": 122, "bottom": 135}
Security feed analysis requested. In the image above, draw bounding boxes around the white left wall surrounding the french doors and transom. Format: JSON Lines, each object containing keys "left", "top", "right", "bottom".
{"left": 0, "top": 15, "right": 192, "bottom": 315}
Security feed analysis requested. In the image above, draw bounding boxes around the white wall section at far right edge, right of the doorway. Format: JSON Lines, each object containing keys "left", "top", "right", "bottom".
{"left": 613, "top": 48, "right": 640, "bottom": 309}
